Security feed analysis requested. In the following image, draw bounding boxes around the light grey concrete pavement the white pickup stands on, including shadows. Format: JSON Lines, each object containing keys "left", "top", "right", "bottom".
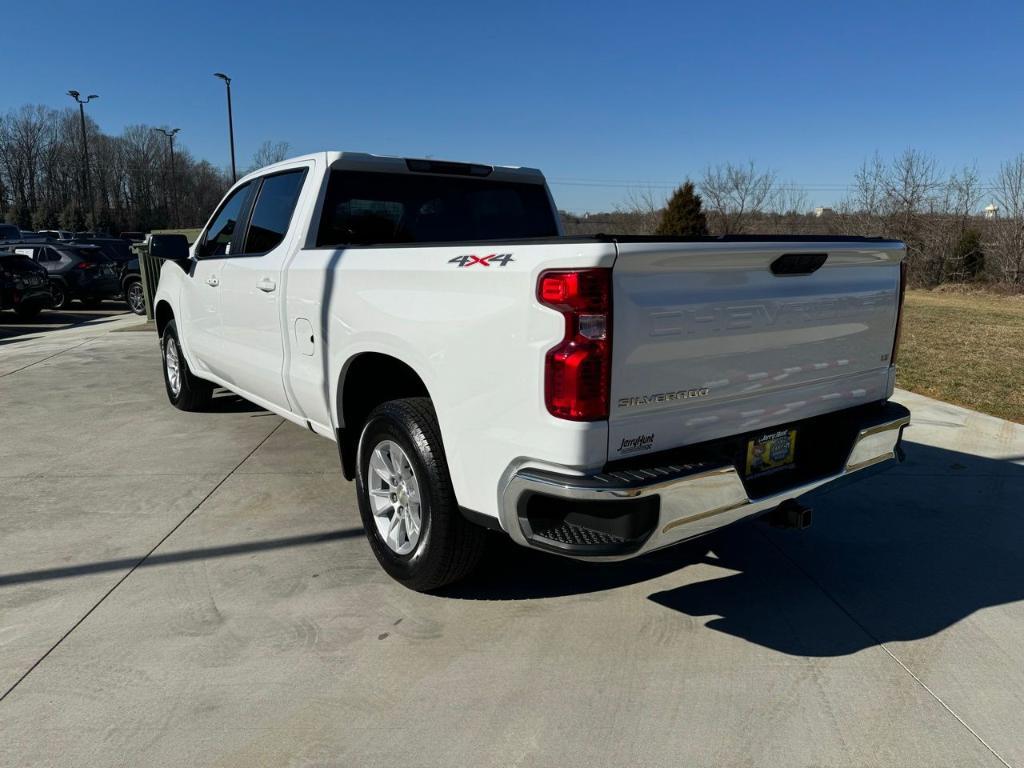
{"left": 0, "top": 321, "right": 1024, "bottom": 768}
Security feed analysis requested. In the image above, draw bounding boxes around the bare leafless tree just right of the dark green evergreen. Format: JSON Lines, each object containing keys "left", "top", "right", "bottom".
{"left": 698, "top": 160, "right": 776, "bottom": 234}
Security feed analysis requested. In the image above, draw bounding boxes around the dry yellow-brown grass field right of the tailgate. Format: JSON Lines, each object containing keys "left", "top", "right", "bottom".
{"left": 896, "top": 291, "right": 1024, "bottom": 424}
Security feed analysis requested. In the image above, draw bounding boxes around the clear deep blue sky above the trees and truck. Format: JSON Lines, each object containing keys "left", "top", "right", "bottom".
{"left": 0, "top": 0, "right": 1024, "bottom": 212}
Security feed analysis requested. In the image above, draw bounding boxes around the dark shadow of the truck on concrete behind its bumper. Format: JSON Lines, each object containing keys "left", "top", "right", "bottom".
{"left": 448, "top": 442, "right": 1024, "bottom": 656}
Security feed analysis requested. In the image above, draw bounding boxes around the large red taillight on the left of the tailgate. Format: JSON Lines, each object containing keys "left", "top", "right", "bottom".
{"left": 537, "top": 269, "right": 611, "bottom": 421}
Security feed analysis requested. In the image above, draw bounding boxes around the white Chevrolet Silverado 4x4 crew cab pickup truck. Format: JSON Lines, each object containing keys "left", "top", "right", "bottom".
{"left": 152, "top": 153, "right": 909, "bottom": 590}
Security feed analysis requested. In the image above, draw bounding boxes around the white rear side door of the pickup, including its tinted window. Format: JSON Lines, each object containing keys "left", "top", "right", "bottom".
{"left": 220, "top": 164, "right": 308, "bottom": 410}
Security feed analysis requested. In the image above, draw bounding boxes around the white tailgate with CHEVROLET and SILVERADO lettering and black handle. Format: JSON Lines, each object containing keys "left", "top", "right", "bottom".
{"left": 608, "top": 241, "right": 904, "bottom": 460}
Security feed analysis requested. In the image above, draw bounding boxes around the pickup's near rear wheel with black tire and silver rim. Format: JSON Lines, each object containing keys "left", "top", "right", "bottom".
{"left": 355, "top": 397, "right": 486, "bottom": 592}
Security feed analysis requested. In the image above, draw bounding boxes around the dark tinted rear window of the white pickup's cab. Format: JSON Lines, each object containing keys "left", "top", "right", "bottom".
{"left": 316, "top": 170, "right": 558, "bottom": 248}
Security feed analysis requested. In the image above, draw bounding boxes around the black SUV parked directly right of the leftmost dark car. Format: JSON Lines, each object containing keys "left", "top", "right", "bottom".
{"left": 12, "top": 241, "right": 121, "bottom": 309}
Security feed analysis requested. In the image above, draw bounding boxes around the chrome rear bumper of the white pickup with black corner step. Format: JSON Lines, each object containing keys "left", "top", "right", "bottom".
{"left": 501, "top": 403, "right": 910, "bottom": 560}
